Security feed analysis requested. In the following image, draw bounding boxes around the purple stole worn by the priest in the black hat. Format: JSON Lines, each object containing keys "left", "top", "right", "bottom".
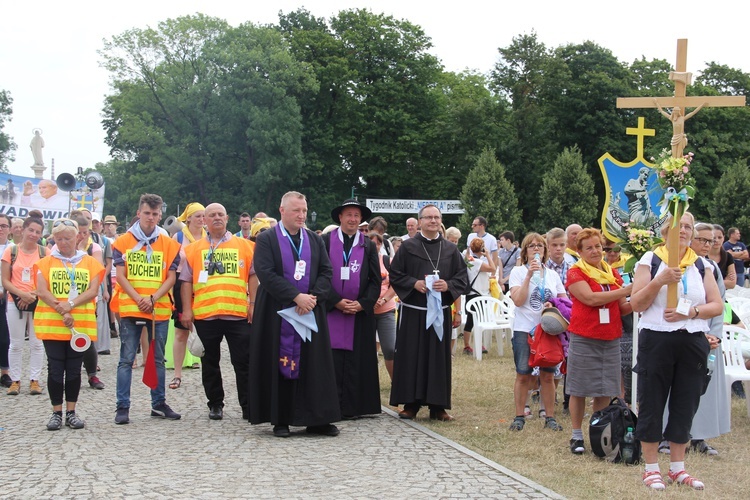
{"left": 328, "top": 230, "right": 365, "bottom": 351}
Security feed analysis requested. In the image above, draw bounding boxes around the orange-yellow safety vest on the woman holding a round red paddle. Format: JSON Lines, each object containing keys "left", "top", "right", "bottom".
{"left": 34, "top": 255, "right": 104, "bottom": 341}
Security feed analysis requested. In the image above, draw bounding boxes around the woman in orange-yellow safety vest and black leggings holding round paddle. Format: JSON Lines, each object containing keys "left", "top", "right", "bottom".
{"left": 34, "top": 219, "right": 104, "bottom": 431}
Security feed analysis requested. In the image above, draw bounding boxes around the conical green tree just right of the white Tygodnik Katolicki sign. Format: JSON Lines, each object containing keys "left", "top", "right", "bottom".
{"left": 458, "top": 148, "right": 524, "bottom": 235}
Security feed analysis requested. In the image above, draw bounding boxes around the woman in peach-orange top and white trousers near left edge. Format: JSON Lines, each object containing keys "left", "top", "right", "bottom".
{"left": 2, "top": 217, "right": 49, "bottom": 396}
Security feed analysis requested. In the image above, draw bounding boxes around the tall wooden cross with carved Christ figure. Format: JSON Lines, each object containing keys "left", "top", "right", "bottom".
{"left": 617, "top": 38, "right": 745, "bottom": 307}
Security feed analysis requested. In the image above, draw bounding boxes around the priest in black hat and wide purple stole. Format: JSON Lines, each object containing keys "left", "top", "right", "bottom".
{"left": 323, "top": 199, "right": 382, "bottom": 419}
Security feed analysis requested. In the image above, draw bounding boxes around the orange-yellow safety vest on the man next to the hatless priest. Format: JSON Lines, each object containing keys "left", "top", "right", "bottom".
{"left": 185, "top": 236, "right": 254, "bottom": 319}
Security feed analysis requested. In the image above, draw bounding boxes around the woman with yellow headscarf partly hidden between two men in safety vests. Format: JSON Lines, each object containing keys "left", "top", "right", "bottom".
{"left": 165, "top": 202, "right": 206, "bottom": 389}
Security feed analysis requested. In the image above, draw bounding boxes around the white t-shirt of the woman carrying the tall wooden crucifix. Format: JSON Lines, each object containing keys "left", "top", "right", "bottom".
{"left": 638, "top": 252, "right": 712, "bottom": 333}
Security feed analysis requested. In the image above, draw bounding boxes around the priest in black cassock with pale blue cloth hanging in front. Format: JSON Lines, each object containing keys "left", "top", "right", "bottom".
{"left": 390, "top": 205, "right": 468, "bottom": 422}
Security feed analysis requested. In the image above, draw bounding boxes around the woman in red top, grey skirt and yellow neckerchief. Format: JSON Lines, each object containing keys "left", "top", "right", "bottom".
{"left": 565, "top": 228, "right": 632, "bottom": 455}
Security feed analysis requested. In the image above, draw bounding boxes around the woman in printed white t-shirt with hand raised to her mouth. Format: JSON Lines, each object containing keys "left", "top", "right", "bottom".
{"left": 508, "top": 233, "right": 567, "bottom": 431}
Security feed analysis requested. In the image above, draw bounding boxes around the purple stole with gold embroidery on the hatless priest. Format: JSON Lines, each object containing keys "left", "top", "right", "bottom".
{"left": 276, "top": 224, "right": 315, "bottom": 379}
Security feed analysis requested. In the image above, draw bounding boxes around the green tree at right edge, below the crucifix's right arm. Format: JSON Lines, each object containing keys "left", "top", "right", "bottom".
{"left": 712, "top": 160, "right": 750, "bottom": 238}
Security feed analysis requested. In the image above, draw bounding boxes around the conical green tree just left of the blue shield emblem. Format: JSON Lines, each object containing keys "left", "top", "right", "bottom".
{"left": 537, "top": 146, "right": 598, "bottom": 231}
